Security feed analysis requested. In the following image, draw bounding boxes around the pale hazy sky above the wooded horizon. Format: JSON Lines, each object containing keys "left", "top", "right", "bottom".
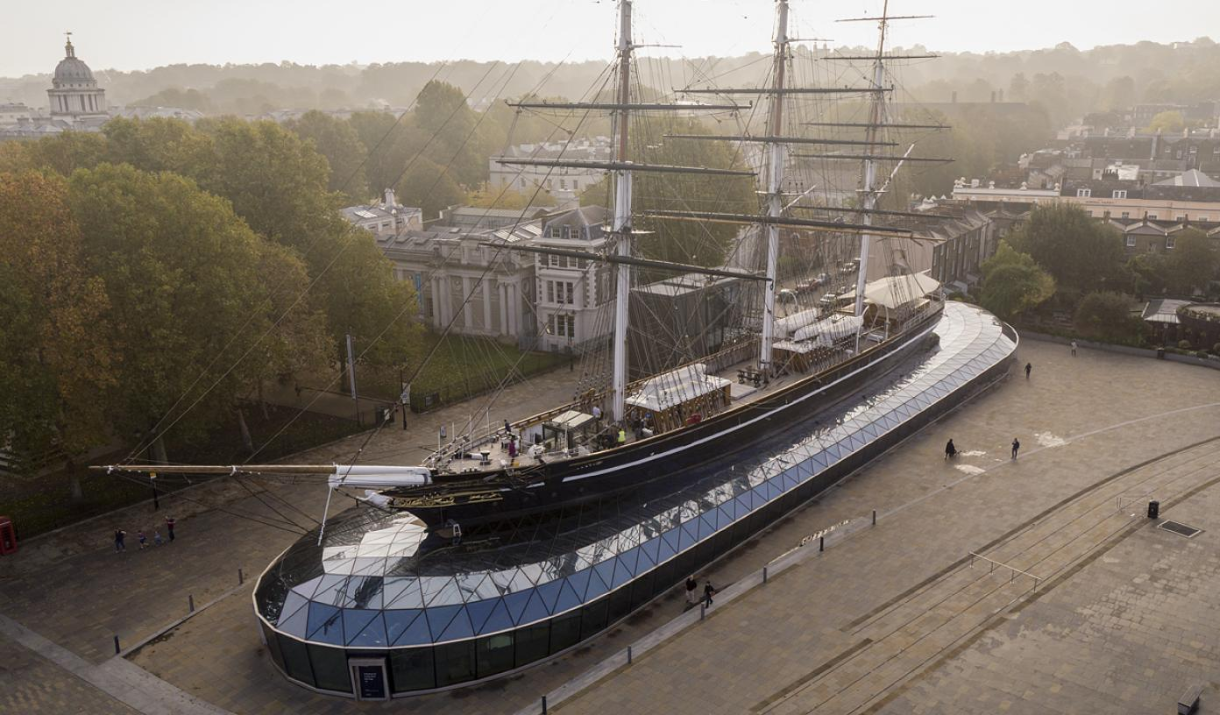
{"left": 0, "top": 0, "right": 1220, "bottom": 77}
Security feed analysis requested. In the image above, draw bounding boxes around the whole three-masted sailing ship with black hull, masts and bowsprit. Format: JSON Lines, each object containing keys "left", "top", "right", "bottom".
{"left": 100, "top": 0, "right": 943, "bottom": 538}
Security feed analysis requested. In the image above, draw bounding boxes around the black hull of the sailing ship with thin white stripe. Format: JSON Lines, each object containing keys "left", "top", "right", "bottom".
{"left": 395, "top": 312, "right": 939, "bottom": 531}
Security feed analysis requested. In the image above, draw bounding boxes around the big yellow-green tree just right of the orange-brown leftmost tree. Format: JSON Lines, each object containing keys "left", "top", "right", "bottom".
{"left": 70, "top": 163, "right": 314, "bottom": 443}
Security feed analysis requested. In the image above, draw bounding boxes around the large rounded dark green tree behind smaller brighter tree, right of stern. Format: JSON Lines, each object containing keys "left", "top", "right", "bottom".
{"left": 1010, "top": 203, "right": 1124, "bottom": 293}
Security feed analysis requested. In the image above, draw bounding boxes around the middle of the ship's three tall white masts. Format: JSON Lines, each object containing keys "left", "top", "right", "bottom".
{"left": 759, "top": 0, "right": 788, "bottom": 376}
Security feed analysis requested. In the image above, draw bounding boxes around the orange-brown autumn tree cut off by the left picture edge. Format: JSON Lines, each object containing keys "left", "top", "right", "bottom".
{"left": 0, "top": 172, "right": 118, "bottom": 488}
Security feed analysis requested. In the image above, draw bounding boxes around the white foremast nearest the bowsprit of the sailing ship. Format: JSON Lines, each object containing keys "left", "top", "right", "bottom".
{"left": 611, "top": 0, "right": 632, "bottom": 423}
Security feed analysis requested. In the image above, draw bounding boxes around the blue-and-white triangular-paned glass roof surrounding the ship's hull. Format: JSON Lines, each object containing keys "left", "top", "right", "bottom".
{"left": 255, "top": 301, "right": 1016, "bottom": 648}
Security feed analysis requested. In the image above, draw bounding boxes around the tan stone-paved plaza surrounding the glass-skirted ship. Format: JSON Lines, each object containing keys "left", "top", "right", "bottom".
{"left": 7, "top": 340, "right": 1220, "bottom": 715}
